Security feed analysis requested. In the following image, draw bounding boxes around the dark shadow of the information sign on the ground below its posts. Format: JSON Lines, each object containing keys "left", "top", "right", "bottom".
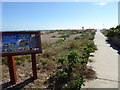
{"left": 0, "top": 77, "right": 35, "bottom": 90}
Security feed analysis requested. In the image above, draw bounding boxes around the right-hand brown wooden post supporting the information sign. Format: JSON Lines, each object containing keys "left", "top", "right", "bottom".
{"left": 31, "top": 54, "right": 37, "bottom": 79}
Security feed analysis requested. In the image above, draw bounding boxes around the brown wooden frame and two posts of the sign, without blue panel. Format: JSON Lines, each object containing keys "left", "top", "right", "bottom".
{"left": 0, "top": 31, "right": 42, "bottom": 84}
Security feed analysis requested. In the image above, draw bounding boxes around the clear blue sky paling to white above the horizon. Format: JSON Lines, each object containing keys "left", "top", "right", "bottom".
{"left": 2, "top": 2, "right": 118, "bottom": 31}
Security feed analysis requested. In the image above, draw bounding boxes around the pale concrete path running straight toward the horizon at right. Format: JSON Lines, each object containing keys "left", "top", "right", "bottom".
{"left": 82, "top": 31, "right": 119, "bottom": 88}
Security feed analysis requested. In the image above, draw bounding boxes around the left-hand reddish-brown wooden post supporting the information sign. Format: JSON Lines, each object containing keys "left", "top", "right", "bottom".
{"left": 7, "top": 56, "right": 17, "bottom": 84}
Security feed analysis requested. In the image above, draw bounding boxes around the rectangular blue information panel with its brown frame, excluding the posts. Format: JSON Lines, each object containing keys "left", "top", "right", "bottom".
{"left": 2, "top": 31, "right": 42, "bottom": 55}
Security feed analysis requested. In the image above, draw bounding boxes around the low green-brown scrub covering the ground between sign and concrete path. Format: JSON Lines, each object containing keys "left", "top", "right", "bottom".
{"left": 2, "top": 30, "right": 96, "bottom": 89}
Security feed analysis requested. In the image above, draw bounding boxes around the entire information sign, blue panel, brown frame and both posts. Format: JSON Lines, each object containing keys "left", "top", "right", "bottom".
{"left": 0, "top": 31, "right": 42, "bottom": 84}
